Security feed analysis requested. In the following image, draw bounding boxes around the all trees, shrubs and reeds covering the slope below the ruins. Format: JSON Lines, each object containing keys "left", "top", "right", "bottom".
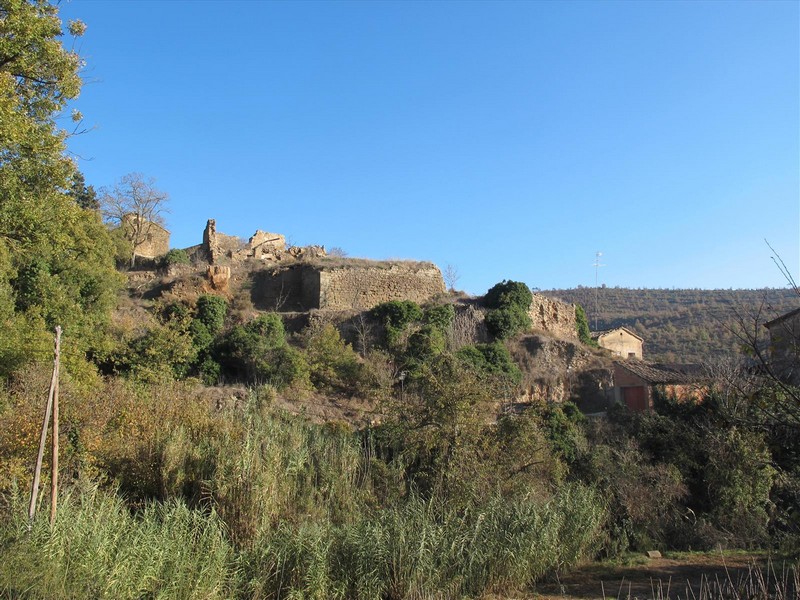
{"left": 0, "top": 0, "right": 800, "bottom": 600}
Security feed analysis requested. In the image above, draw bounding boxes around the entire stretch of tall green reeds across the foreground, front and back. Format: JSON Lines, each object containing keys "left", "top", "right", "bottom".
{"left": 0, "top": 389, "right": 605, "bottom": 599}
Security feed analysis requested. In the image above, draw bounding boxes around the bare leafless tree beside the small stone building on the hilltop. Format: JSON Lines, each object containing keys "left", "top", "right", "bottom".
{"left": 100, "top": 173, "right": 169, "bottom": 267}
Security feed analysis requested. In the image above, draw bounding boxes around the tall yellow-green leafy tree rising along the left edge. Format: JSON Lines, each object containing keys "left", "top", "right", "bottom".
{"left": 0, "top": 0, "right": 120, "bottom": 375}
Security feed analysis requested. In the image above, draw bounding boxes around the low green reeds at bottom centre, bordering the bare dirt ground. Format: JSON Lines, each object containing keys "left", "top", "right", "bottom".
{"left": 244, "top": 486, "right": 605, "bottom": 599}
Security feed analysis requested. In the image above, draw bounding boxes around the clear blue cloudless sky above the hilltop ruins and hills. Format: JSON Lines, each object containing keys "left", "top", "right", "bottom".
{"left": 61, "top": 0, "right": 800, "bottom": 294}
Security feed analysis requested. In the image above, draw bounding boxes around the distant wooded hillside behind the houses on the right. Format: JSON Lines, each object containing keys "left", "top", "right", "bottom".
{"left": 542, "top": 287, "right": 800, "bottom": 362}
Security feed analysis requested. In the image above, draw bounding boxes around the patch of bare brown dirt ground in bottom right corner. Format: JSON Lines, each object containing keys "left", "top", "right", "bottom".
{"left": 504, "top": 553, "right": 800, "bottom": 600}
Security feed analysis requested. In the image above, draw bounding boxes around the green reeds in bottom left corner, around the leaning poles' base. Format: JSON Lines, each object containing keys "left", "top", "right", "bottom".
{"left": 0, "top": 487, "right": 236, "bottom": 600}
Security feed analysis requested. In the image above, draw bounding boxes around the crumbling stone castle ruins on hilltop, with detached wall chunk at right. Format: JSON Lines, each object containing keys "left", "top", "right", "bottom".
{"left": 177, "top": 219, "right": 576, "bottom": 339}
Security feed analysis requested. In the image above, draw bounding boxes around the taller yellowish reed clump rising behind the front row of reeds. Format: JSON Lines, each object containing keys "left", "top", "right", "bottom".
{"left": 160, "top": 389, "right": 370, "bottom": 546}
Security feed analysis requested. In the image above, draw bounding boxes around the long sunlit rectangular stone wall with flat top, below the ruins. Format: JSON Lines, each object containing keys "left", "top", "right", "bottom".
{"left": 318, "top": 260, "right": 445, "bottom": 310}
